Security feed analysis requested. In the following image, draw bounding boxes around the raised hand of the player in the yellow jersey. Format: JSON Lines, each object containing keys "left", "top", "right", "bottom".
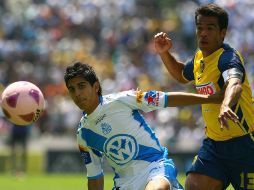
{"left": 154, "top": 32, "right": 173, "bottom": 54}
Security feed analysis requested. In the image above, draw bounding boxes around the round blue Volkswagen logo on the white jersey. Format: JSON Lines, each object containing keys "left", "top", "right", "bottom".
{"left": 104, "top": 134, "right": 138, "bottom": 165}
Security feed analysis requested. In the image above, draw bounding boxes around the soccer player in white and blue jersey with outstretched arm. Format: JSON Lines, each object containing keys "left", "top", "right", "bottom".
{"left": 64, "top": 62, "right": 226, "bottom": 190}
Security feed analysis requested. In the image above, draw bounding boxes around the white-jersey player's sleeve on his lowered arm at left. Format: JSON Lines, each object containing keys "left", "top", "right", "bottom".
{"left": 77, "top": 125, "right": 103, "bottom": 179}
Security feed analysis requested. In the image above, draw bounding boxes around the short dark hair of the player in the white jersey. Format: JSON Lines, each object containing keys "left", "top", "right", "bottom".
{"left": 64, "top": 62, "right": 102, "bottom": 96}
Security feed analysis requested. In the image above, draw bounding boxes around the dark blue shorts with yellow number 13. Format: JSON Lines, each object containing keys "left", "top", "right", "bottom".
{"left": 187, "top": 132, "right": 254, "bottom": 190}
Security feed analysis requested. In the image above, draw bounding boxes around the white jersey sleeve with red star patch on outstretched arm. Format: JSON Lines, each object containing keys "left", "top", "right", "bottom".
{"left": 110, "top": 90, "right": 168, "bottom": 112}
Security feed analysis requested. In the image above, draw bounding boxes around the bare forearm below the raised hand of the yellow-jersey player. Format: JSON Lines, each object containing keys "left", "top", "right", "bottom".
{"left": 159, "top": 52, "right": 187, "bottom": 83}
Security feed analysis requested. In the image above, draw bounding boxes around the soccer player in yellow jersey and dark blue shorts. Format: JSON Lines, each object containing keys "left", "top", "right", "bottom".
{"left": 154, "top": 4, "right": 254, "bottom": 190}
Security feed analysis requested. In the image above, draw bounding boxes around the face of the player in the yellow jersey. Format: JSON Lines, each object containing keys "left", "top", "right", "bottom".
{"left": 196, "top": 15, "right": 226, "bottom": 57}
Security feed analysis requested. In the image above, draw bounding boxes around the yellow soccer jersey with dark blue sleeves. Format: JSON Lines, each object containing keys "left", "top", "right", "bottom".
{"left": 183, "top": 44, "right": 254, "bottom": 141}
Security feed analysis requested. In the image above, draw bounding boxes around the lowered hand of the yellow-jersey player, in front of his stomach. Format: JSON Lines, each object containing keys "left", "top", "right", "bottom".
{"left": 218, "top": 104, "right": 239, "bottom": 130}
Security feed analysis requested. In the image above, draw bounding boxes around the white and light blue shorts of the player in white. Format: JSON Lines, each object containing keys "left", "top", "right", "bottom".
{"left": 115, "top": 159, "right": 183, "bottom": 190}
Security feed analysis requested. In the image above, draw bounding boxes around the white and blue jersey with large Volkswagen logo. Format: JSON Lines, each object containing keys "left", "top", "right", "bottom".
{"left": 77, "top": 90, "right": 168, "bottom": 179}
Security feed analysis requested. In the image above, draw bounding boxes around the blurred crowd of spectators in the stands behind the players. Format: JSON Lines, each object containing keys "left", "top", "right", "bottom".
{"left": 0, "top": 0, "right": 254, "bottom": 151}
